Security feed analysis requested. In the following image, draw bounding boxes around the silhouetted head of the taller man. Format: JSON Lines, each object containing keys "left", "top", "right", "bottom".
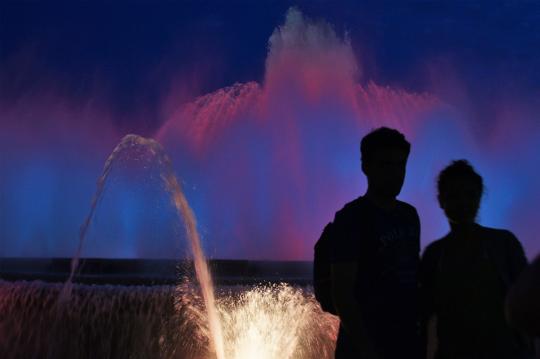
{"left": 360, "top": 127, "right": 411, "bottom": 198}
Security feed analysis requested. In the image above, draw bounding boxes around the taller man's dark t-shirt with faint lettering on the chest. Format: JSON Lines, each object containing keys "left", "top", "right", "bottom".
{"left": 331, "top": 197, "right": 420, "bottom": 358}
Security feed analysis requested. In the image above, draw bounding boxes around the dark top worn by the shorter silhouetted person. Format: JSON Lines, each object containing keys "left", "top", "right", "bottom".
{"left": 421, "top": 226, "right": 528, "bottom": 359}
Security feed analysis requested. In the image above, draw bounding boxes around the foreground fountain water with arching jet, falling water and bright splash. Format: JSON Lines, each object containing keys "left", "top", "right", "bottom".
{"left": 0, "top": 135, "right": 337, "bottom": 359}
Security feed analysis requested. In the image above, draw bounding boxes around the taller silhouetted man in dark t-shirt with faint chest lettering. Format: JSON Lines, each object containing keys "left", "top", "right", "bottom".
{"left": 331, "top": 127, "right": 420, "bottom": 359}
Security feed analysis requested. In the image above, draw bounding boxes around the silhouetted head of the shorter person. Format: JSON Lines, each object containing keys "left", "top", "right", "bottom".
{"left": 437, "top": 160, "right": 484, "bottom": 224}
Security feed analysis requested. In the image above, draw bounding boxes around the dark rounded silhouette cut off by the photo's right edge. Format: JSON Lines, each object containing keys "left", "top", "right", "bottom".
{"left": 506, "top": 256, "right": 540, "bottom": 336}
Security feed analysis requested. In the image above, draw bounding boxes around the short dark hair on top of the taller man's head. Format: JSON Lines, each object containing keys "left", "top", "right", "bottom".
{"left": 360, "top": 127, "right": 411, "bottom": 163}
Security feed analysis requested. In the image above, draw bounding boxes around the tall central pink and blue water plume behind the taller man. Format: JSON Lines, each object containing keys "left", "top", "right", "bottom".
{"left": 156, "top": 8, "right": 441, "bottom": 260}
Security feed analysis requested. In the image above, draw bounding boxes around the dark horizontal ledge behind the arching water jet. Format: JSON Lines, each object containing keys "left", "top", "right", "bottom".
{"left": 0, "top": 258, "right": 313, "bottom": 286}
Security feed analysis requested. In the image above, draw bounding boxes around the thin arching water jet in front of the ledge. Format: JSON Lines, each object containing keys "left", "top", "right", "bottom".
{"left": 59, "top": 134, "right": 225, "bottom": 359}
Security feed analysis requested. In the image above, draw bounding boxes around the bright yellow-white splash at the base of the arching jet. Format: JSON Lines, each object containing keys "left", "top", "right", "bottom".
{"left": 218, "top": 284, "right": 338, "bottom": 359}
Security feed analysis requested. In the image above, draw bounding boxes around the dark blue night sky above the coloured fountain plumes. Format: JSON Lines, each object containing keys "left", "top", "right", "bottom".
{"left": 0, "top": 1, "right": 540, "bottom": 131}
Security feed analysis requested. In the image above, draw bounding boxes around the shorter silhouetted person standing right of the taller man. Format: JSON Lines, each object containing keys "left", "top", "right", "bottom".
{"left": 420, "top": 160, "right": 531, "bottom": 359}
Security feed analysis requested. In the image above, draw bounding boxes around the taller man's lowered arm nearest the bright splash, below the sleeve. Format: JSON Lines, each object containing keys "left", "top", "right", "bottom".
{"left": 331, "top": 262, "right": 378, "bottom": 359}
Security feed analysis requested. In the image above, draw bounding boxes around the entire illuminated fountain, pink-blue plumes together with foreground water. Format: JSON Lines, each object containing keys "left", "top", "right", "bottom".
{"left": 4, "top": 4, "right": 540, "bottom": 359}
